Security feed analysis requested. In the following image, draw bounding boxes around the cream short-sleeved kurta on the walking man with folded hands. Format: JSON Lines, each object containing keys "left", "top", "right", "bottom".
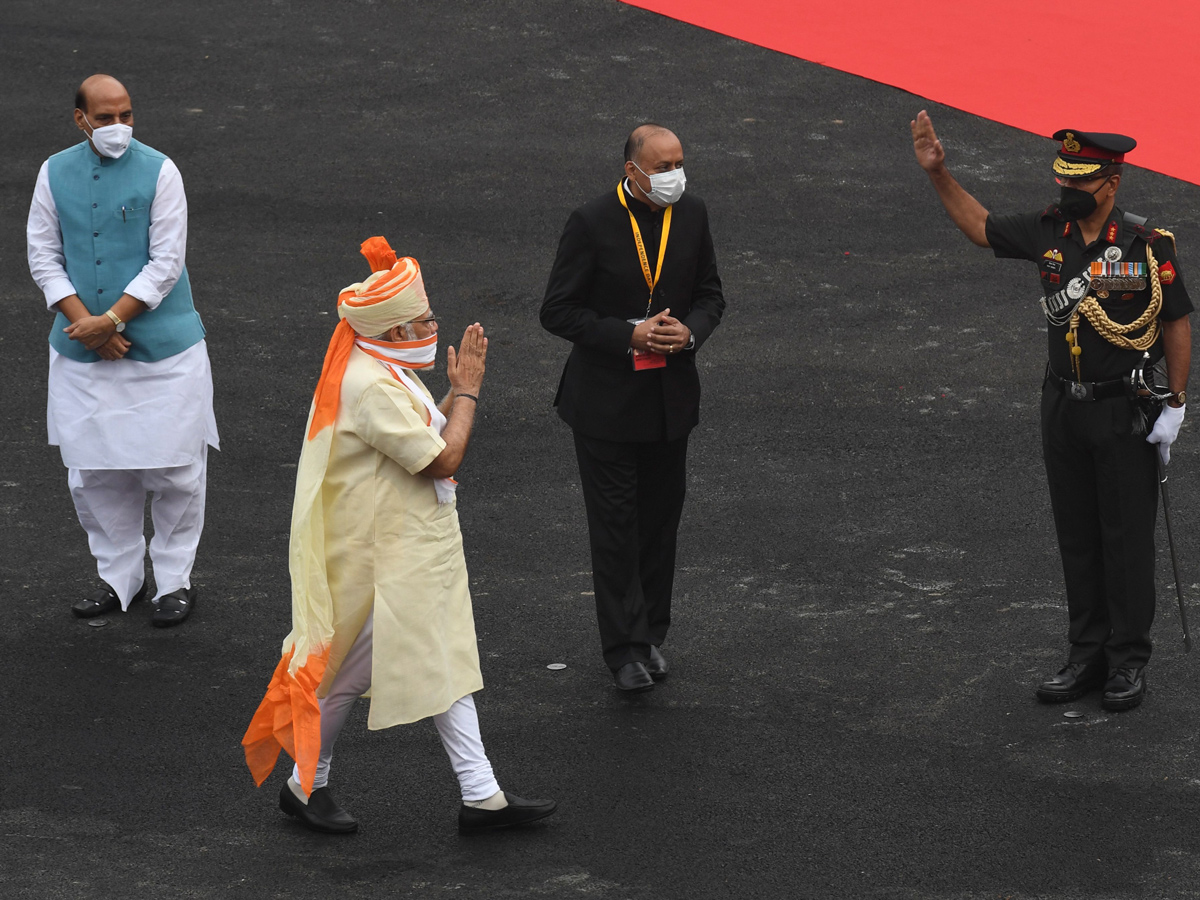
{"left": 317, "top": 348, "right": 484, "bottom": 728}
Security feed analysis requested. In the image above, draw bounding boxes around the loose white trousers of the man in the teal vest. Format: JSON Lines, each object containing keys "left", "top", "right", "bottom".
{"left": 67, "top": 446, "right": 209, "bottom": 610}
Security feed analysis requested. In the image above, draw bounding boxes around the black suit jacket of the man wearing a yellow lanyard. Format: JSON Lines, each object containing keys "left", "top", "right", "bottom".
{"left": 541, "top": 187, "right": 725, "bottom": 442}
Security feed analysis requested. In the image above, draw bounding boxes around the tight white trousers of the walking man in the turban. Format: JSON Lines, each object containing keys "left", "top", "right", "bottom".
{"left": 292, "top": 616, "right": 500, "bottom": 802}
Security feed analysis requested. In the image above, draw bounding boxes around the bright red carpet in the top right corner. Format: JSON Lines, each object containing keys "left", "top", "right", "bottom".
{"left": 624, "top": 0, "right": 1200, "bottom": 184}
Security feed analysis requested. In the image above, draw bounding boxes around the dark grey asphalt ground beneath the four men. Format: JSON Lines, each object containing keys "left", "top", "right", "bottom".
{"left": 0, "top": 0, "right": 1200, "bottom": 900}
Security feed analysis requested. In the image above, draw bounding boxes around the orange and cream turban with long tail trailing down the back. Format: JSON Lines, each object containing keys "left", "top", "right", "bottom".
{"left": 241, "top": 238, "right": 430, "bottom": 793}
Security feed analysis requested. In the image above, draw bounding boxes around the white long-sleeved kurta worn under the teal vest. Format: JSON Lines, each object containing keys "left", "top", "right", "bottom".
{"left": 25, "top": 150, "right": 220, "bottom": 469}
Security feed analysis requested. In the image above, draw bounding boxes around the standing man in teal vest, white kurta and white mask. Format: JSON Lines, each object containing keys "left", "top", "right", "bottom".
{"left": 26, "top": 74, "right": 218, "bottom": 626}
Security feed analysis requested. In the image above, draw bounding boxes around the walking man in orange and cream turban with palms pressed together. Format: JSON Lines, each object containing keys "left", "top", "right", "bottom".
{"left": 242, "top": 238, "right": 556, "bottom": 833}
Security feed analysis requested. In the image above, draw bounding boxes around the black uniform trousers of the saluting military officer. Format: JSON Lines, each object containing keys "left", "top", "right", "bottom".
{"left": 1042, "top": 382, "right": 1158, "bottom": 670}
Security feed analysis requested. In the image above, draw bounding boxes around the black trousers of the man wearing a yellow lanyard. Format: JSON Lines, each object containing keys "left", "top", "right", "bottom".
{"left": 575, "top": 432, "right": 688, "bottom": 670}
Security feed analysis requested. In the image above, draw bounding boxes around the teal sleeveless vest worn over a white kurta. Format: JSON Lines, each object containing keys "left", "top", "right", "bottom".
{"left": 48, "top": 140, "right": 204, "bottom": 362}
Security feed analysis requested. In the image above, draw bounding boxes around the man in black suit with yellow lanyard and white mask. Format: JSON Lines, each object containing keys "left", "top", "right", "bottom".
{"left": 541, "top": 124, "right": 725, "bottom": 691}
